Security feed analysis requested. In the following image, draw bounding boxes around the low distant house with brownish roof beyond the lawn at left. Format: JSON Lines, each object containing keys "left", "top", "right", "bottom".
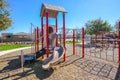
{"left": 1, "top": 32, "right": 32, "bottom": 42}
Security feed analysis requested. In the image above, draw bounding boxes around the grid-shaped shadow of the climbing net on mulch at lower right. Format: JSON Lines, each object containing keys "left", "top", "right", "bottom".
{"left": 72, "top": 58, "right": 120, "bottom": 80}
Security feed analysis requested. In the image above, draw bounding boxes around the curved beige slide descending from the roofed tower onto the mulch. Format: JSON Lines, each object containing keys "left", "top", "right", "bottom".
{"left": 42, "top": 46, "right": 65, "bottom": 70}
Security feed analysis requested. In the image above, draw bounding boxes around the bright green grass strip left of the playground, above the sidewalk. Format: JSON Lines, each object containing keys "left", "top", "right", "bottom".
{"left": 0, "top": 44, "right": 31, "bottom": 51}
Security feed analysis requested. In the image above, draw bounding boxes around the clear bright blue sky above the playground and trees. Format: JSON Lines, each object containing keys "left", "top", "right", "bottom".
{"left": 3, "top": 0, "right": 120, "bottom": 33}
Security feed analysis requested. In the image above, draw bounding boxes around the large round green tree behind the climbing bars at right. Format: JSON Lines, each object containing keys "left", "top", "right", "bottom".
{"left": 85, "top": 18, "right": 112, "bottom": 35}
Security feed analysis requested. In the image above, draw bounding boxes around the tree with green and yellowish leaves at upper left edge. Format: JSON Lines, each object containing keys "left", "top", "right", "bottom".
{"left": 0, "top": 0, "right": 12, "bottom": 31}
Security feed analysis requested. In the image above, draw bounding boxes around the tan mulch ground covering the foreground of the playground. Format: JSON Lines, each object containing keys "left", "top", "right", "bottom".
{"left": 0, "top": 46, "right": 120, "bottom": 80}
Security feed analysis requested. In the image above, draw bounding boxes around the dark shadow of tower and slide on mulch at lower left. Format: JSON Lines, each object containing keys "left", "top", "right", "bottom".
{"left": 0, "top": 57, "right": 54, "bottom": 80}
